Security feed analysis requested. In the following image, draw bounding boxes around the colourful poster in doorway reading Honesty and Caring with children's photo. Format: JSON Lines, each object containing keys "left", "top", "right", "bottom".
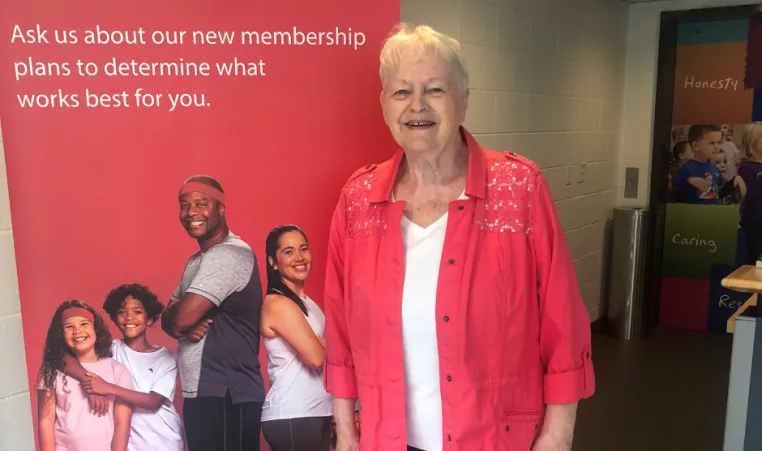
{"left": 659, "top": 19, "right": 762, "bottom": 332}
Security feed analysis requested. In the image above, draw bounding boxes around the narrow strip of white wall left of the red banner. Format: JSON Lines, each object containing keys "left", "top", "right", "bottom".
{"left": 0, "top": 124, "right": 34, "bottom": 451}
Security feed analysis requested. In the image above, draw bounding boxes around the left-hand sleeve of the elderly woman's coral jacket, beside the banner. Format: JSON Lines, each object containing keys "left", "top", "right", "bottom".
{"left": 323, "top": 194, "right": 357, "bottom": 399}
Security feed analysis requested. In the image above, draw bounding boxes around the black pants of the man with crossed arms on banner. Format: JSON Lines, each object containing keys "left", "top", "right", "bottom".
{"left": 183, "top": 395, "right": 262, "bottom": 451}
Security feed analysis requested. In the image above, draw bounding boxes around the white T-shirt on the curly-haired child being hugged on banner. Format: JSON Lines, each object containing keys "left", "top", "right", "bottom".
{"left": 111, "top": 340, "right": 185, "bottom": 451}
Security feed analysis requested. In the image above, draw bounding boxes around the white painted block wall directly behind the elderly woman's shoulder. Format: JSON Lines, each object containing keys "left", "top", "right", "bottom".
{"left": 402, "top": 0, "right": 627, "bottom": 320}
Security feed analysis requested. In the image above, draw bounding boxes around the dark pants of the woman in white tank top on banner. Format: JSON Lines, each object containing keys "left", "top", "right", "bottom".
{"left": 262, "top": 417, "right": 331, "bottom": 451}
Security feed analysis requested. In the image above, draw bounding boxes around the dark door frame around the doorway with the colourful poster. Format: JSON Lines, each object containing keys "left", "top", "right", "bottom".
{"left": 643, "top": 4, "right": 762, "bottom": 335}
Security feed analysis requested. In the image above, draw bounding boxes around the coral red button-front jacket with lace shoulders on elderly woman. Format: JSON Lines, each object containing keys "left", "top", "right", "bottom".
{"left": 324, "top": 130, "right": 595, "bottom": 451}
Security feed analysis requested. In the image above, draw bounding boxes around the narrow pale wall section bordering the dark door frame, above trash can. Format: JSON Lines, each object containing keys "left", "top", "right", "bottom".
{"left": 617, "top": 0, "right": 759, "bottom": 206}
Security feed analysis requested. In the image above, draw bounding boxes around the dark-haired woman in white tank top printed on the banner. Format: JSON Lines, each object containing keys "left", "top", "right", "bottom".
{"left": 260, "top": 225, "right": 333, "bottom": 451}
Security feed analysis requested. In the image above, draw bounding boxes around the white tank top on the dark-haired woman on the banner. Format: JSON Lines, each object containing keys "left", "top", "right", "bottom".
{"left": 262, "top": 297, "right": 333, "bottom": 421}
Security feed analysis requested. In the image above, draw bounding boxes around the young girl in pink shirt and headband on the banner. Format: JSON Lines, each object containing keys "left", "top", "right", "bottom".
{"left": 37, "top": 301, "right": 133, "bottom": 451}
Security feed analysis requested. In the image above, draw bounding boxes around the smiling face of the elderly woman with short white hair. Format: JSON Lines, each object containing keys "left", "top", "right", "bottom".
{"left": 381, "top": 53, "right": 468, "bottom": 152}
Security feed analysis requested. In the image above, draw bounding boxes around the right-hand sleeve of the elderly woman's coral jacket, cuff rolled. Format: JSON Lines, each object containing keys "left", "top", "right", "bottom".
{"left": 531, "top": 173, "right": 595, "bottom": 404}
